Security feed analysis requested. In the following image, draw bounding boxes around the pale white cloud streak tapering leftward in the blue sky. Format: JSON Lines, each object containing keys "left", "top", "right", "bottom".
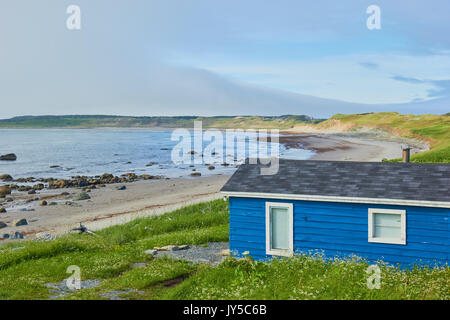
{"left": 202, "top": 54, "right": 450, "bottom": 104}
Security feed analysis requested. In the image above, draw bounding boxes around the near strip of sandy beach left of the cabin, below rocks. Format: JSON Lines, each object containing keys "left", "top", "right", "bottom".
{"left": 0, "top": 175, "right": 229, "bottom": 243}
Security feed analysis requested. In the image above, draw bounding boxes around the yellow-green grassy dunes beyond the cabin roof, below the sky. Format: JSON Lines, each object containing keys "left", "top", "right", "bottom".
{"left": 316, "top": 112, "right": 450, "bottom": 163}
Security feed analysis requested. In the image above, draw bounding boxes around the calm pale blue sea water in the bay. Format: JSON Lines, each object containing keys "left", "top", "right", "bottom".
{"left": 0, "top": 129, "right": 313, "bottom": 182}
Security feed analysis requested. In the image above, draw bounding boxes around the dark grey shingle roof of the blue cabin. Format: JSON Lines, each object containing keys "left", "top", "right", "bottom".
{"left": 221, "top": 159, "right": 450, "bottom": 202}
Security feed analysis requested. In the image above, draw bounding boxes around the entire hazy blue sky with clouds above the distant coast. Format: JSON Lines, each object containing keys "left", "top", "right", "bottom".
{"left": 0, "top": 0, "right": 450, "bottom": 118}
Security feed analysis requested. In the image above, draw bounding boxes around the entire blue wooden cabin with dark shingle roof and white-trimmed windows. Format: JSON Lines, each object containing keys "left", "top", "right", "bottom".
{"left": 222, "top": 159, "right": 450, "bottom": 267}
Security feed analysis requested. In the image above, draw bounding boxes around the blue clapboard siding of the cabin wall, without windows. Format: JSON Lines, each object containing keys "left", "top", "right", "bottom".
{"left": 230, "top": 197, "right": 450, "bottom": 267}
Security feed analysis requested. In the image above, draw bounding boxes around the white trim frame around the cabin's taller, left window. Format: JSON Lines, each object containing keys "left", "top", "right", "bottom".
{"left": 266, "top": 202, "right": 294, "bottom": 257}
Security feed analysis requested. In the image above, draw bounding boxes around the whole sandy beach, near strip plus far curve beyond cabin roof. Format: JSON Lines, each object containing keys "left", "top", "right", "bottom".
{"left": 0, "top": 130, "right": 428, "bottom": 241}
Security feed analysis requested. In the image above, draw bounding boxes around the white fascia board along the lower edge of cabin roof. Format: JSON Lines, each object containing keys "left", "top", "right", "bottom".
{"left": 221, "top": 191, "right": 450, "bottom": 209}
